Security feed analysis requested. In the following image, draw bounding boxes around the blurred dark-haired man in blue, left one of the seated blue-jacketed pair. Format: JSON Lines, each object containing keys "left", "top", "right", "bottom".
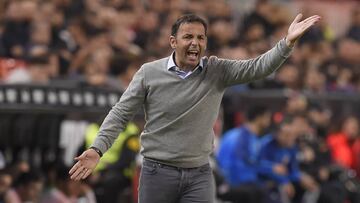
{"left": 217, "top": 106, "right": 271, "bottom": 203}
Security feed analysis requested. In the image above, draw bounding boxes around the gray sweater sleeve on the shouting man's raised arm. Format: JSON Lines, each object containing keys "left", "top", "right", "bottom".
{"left": 217, "top": 39, "right": 292, "bottom": 87}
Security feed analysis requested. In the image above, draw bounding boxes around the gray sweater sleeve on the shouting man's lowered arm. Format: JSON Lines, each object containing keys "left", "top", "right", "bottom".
{"left": 92, "top": 67, "right": 146, "bottom": 153}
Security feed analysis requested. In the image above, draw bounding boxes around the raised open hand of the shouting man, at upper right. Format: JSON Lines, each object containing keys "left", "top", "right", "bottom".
{"left": 286, "top": 13, "right": 321, "bottom": 47}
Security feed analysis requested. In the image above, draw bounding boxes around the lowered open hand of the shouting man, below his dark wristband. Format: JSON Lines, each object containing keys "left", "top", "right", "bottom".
{"left": 69, "top": 149, "right": 100, "bottom": 180}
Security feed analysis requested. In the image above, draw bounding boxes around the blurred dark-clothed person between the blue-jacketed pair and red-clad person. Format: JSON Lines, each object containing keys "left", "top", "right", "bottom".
{"left": 297, "top": 114, "right": 347, "bottom": 203}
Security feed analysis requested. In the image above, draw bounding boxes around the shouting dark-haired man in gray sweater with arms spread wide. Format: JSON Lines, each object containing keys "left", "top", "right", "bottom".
{"left": 69, "top": 15, "right": 320, "bottom": 203}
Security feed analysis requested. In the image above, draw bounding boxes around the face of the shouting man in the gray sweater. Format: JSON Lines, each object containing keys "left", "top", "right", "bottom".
{"left": 170, "top": 22, "right": 207, "bottom": 70}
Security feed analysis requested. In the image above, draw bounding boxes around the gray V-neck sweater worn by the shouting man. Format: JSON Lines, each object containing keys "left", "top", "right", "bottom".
{"left": 93, "top": 39, "right": 291, "bottom": 168}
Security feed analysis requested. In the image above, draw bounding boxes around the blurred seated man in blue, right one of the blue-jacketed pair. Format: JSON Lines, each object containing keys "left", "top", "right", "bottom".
{"left": 258, "top": 115, "right": 319, "bottom": 203}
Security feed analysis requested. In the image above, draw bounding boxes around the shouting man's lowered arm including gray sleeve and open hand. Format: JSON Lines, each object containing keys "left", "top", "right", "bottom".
{"left": 69, "top": 68, "right": 146, "bottom": 180}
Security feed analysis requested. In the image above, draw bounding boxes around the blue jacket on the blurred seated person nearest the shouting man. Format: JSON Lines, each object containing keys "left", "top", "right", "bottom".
{"left": 217, "top": 127, "right": 260, "bottom": 186}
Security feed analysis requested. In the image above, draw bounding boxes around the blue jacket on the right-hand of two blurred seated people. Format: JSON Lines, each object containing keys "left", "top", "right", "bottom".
{"left": 258, "top": 135, "right": 300, "bottom": 184}
